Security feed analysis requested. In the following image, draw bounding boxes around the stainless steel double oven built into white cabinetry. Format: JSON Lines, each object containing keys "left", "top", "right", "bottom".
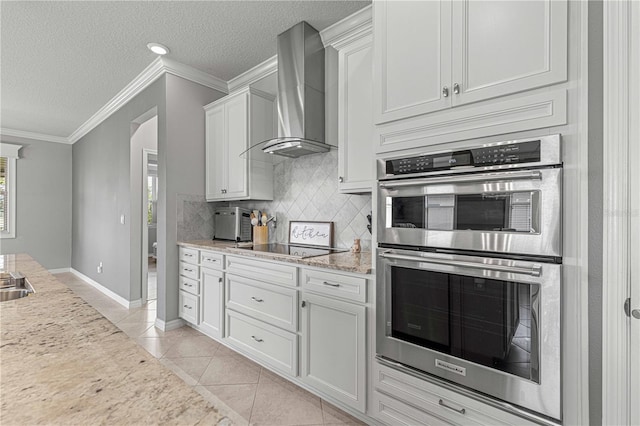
{"left": 376, "top": 135, "right": 562, "bottom": 420}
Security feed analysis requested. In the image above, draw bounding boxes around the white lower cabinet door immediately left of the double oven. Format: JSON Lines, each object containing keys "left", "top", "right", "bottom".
{"left": 300, "top": 294, "right": 367, "bottom": 412}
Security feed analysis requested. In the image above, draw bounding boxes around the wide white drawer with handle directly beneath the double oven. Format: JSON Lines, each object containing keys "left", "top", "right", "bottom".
{"left": 373, "top": 362, "right": 534, "bottom": 425}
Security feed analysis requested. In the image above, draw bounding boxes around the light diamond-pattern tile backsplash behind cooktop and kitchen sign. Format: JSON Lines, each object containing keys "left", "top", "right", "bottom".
{"left": 231, "top": 149, "right": 371, "bottom": 250}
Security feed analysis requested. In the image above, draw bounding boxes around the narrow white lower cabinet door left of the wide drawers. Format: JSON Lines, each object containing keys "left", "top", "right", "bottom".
{"left": 200, "top": 268, "right": 224, "bottom": 339}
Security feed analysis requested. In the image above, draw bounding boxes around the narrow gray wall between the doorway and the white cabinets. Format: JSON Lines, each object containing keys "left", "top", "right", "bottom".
{"left": 157, "top": 74, "right": 224, "bottom": 321}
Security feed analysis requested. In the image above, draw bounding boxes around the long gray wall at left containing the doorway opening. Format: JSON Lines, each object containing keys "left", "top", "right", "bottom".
{"left": 71, "top": 77, "right": 166, "bottom": 300}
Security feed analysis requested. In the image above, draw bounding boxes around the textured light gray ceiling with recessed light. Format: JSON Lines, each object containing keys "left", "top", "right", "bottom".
{"left": 0, "top": 0, "right": 370, "bottom": 137}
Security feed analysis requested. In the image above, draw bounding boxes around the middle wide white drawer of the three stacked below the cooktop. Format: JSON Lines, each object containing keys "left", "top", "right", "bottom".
{"left": 226, "top": 274, "right": 298, "bottom": 332}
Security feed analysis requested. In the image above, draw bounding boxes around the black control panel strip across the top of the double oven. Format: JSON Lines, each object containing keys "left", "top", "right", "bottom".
{"left": 385, "top": 139, "right": 541, "bottom": 176}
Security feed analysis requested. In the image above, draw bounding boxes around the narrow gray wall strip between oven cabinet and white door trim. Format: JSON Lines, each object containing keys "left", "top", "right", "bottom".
{"left": 588, "top": 1, "right": 604, "bottom": 425}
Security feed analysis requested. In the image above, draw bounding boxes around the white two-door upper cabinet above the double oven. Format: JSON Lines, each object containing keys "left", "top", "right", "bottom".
{"left": 373, "top": 0, "right": 567, "bottom": 124}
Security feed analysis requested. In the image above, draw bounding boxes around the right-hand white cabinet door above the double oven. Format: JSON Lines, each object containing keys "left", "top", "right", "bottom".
{"left": 452, "top": 0, "right": 567, "bottom": 105}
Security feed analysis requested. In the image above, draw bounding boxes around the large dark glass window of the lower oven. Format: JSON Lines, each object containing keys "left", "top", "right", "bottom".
{"left": 391, "top": 267, "right": 538, "bottom": 381}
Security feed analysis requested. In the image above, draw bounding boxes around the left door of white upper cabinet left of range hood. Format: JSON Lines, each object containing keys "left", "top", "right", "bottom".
{"left": 205, "top": 105, "right": 226, "bottom": 201}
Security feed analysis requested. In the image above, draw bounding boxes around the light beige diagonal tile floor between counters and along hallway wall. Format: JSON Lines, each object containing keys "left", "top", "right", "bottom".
{"left": 56, "top": 273, "right": 364, "bottom": 426}
